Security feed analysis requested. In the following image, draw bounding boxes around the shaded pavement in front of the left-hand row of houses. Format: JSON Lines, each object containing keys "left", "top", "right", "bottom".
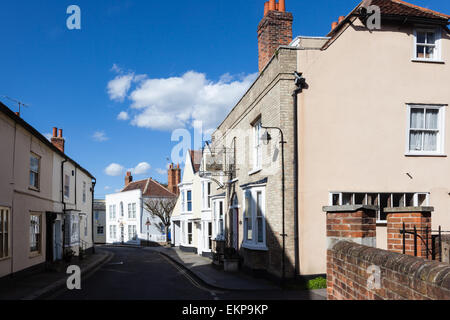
{"left": 0, "top": 249, "right": 113, "bottom": 300}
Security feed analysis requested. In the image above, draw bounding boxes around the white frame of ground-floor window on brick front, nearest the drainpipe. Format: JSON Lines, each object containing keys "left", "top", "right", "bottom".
{"left": 242, "top": 187, "right": 268, "bottom": 251}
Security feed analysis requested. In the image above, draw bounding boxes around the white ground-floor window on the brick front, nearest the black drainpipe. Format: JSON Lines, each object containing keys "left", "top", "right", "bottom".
{"left": 244, "top": 187, "right": 266, "bottom": 247}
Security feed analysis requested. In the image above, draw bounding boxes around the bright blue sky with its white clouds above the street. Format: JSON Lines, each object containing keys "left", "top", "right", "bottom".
{"left": 0, "top": 0, "right": 450, "bottom": 197}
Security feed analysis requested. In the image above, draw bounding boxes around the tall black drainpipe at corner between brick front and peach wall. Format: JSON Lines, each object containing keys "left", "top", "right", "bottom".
{"left": 292, "top": 72, "right": 305, "bottom": 276}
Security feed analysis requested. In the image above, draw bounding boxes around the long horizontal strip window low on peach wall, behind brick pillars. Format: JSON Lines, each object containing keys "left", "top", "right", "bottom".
{"left": 330, "top": 192, "right": 430, "bottom": 223}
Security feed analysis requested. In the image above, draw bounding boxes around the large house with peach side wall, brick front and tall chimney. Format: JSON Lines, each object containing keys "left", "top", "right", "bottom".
{"left": 202, "top": 0, "right": 450, "bottom": 278}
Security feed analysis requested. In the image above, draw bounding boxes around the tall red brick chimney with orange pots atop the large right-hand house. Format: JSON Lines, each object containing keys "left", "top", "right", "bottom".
{"left": 258, "top": 0, "right": 294, "bottom": 72}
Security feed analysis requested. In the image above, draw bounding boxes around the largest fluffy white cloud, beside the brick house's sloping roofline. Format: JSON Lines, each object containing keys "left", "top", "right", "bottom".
{"left": 108, "top": 71, "right": 257, "bottom": 131}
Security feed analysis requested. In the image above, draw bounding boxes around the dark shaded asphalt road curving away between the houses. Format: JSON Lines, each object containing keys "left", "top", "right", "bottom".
{"left": 47, "top": 247, "right": 323, "bottom": 300}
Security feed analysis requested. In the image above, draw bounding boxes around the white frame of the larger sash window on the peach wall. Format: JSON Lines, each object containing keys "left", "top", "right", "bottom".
{"left": 405, "top": 104, "right": 446, "bottom": 156}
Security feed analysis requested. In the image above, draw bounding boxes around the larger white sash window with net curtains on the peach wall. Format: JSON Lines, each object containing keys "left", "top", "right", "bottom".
{"left": 407, "top": 105, "right": 444, "bottom": 155}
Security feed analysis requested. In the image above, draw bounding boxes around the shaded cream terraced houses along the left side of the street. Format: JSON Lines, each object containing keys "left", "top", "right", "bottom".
{"left": 0, "top": 103, "right": 95, "bottom": 278}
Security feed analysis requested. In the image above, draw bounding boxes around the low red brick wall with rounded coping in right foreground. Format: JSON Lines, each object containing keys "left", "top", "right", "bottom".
{"left": 327, "top": 241, "right": 450, "bottom": 300}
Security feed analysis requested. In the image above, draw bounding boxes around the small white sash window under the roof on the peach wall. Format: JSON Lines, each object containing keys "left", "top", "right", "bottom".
{"left": 414, "top": 28, "right": 441, "bottom": 61}
